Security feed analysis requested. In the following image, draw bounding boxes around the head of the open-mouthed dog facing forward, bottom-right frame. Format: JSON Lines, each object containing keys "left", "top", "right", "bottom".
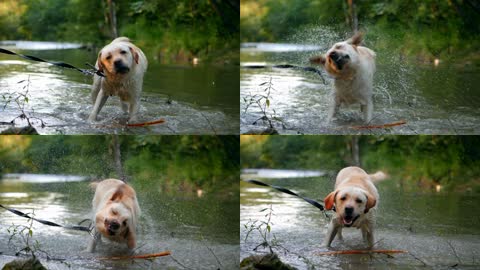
{"left": 324, "top": 186, "right": 376, "bottom": 227}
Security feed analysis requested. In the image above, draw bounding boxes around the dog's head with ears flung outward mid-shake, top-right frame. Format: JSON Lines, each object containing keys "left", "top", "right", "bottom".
{"left": 310, "top": 32, "right": 363, "bottom": 77}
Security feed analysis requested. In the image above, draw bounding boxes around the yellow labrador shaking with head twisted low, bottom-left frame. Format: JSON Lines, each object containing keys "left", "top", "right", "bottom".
{"left": 88, "top": 179, "right": 140, "bottom": 252}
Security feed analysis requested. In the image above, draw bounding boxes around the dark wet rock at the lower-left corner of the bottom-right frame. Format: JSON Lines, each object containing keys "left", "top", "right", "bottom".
{"left": 240, "top": 253, "right": 297, "bottom": 270}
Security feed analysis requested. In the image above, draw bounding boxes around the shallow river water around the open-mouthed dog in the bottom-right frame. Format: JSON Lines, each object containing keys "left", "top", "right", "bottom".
{"left": 240, "top": 171, "right": 480, "bottom": 269}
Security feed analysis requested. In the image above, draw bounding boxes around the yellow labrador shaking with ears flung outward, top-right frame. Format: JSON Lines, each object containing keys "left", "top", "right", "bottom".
{"left": 310, "top": 33, "right": 375, "bottom": 123}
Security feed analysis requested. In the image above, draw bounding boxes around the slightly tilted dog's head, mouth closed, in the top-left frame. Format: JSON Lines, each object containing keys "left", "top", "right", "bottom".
{"left": 97, "top": 37, "right": 139, "bottom": 77}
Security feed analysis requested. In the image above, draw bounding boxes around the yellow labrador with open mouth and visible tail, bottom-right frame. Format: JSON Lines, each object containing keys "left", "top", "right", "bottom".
{"left": 324, "top": 167, "right": 386, "bottom": 248}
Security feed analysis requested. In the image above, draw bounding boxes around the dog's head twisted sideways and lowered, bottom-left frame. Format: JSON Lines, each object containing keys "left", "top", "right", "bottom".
{"left": 95, "top": 185, "right": 135, "bottom": 239}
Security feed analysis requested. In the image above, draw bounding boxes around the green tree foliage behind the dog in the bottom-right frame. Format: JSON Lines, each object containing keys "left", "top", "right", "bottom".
{"left": 240, "top": 136, "right": 480, "bottom": 191}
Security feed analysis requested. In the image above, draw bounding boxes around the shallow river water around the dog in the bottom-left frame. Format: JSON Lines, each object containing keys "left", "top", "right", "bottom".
{"left": 0, "top": 175, "right": 239, "bottom": 269}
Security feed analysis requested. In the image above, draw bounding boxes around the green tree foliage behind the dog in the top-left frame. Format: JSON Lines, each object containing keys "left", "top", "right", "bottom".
{"left": 0, "top": 0, "right": 239, "bottom": 60}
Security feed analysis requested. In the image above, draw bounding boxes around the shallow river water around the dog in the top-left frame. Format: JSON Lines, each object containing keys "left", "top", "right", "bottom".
{"left": 0, "top": 42, "right": 239, "bottom": 134}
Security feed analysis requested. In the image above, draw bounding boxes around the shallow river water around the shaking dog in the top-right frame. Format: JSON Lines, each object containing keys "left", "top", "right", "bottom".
{"left": 240, "top": 42, "right": 480, "bottom": 134}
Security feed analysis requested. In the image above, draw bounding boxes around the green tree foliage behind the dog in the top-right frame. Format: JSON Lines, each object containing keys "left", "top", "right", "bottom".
{"left": 240, "top": 0, "right": 480, "bottom": 60}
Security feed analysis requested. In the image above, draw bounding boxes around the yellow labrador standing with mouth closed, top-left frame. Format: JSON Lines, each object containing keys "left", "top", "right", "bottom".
{"left": 88, "top": 37, "right": 148, "bottom": 122}
